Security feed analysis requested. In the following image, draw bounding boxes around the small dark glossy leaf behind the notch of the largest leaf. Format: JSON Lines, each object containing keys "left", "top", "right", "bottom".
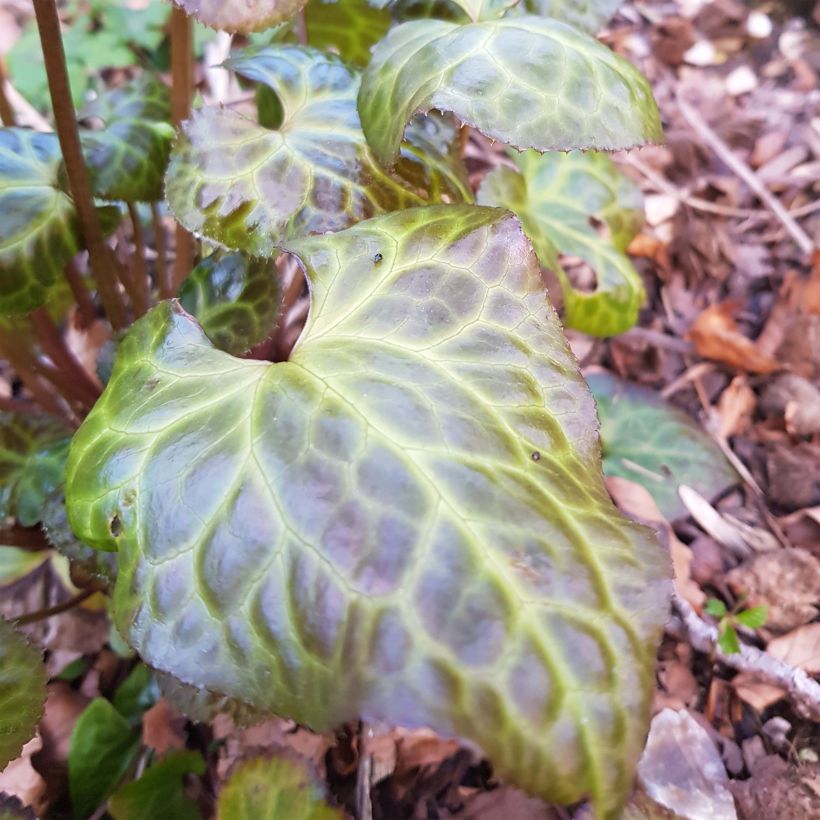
{"left": 179, "top": 252, "right": 279, "bottom": 356}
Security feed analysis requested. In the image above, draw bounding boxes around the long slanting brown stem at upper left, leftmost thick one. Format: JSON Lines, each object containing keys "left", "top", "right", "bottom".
{"left": 34, "top": 0, "right": 128, "bottom": 330}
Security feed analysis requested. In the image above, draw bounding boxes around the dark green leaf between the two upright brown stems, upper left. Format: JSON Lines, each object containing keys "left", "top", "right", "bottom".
{"left": 80, "top": 75, "right": 174, "bottom": 202}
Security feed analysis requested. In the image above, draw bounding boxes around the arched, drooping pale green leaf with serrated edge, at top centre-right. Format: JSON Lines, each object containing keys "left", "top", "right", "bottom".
{"left": 359, "top": 16, "right": 661, "bottom": 165}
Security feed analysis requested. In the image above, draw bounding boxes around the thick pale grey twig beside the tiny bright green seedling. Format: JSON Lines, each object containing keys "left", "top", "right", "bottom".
{"left": 668, "top": 595, "right": 820, "bottom": 720}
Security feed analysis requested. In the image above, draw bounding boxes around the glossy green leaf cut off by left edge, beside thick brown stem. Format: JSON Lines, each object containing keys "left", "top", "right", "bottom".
{"left": 0, "top": 128, "right": 81, "bottom": 314}
